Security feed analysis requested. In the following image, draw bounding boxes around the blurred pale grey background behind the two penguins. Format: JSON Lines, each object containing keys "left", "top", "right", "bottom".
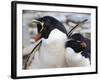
{"left": 22, "top": 10, "right": 91, "bottom": 48}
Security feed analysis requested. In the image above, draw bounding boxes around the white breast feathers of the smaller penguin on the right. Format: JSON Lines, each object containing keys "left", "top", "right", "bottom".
{"left": 65, "top": 47, "right": 90, "bottom": 67}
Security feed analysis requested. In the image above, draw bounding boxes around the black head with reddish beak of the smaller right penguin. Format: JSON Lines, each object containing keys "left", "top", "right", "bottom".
{"left": 66, "top": 33, "right": 87, "bottom": 53}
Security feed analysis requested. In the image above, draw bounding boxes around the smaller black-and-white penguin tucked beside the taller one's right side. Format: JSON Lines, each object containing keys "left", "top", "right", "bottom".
{"left": 65, "top": 33, "right": 91, "bottom": 67}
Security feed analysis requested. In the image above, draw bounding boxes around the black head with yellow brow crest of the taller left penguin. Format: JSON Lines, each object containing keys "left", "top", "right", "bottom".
{"left": 33, "top": 16, "right": 67, "bottom": 39}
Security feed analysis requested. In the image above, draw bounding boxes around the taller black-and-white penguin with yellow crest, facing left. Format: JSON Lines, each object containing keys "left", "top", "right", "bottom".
{"left": 28, "top": 16, "right": 68, "bottom": 69}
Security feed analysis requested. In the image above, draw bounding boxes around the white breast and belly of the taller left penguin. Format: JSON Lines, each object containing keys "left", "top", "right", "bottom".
{"left": 28, "top": 29, "right": 67, "bottom": 69}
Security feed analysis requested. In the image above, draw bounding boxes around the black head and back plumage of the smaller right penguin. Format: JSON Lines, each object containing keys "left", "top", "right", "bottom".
{"left": 66, "top": 33, "right": 91, "bottom": 60}
